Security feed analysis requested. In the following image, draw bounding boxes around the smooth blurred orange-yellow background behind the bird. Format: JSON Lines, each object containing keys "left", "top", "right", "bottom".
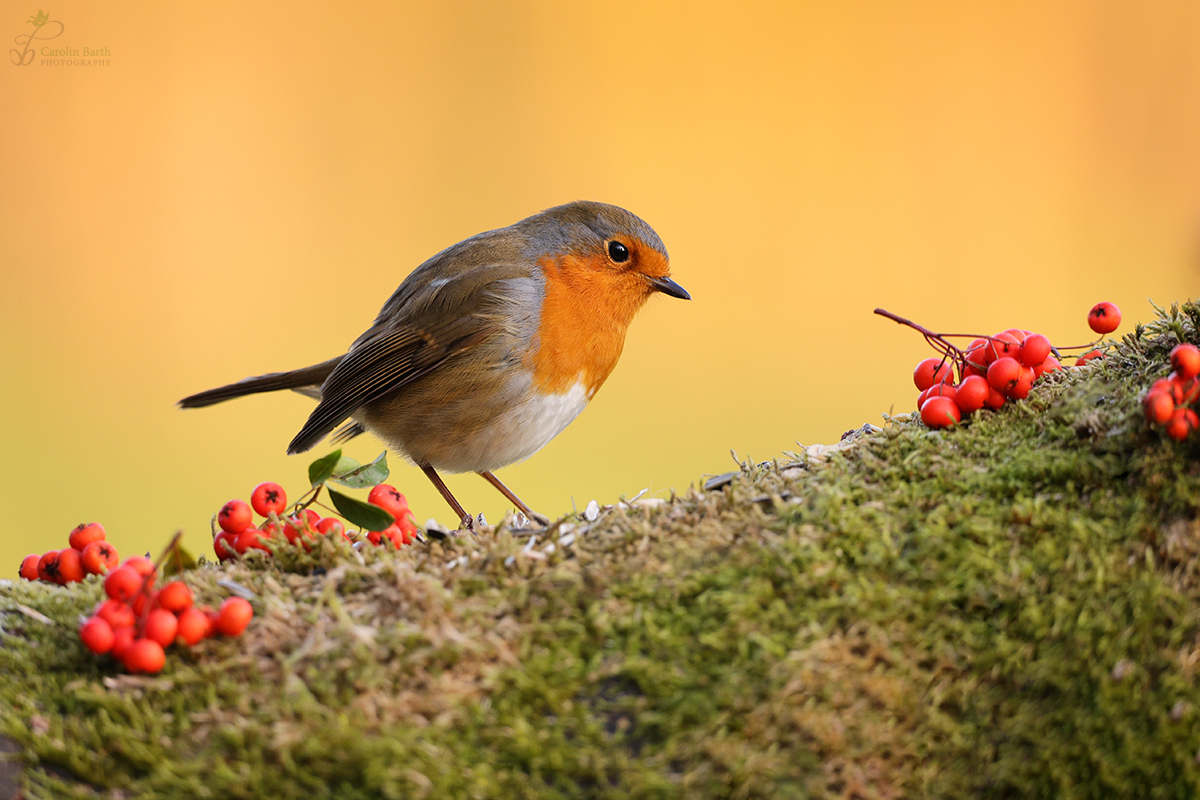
{"left": 0, "top": 0, "right": 1200, "bottom": 577}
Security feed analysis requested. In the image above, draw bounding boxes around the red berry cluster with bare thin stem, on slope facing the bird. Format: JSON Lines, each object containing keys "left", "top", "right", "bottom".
{"left": 875, "top": 302, "right": 1121, "bottom": 428}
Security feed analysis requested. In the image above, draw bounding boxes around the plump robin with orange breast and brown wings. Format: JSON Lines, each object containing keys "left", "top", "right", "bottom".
{"left": 179, "top": 201, "right": 691, "bottom": 528}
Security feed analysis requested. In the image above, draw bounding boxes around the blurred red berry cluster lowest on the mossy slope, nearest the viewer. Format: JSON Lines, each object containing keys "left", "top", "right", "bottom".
{"left": 79, "top": 555, "right": 254, "bottom": 673}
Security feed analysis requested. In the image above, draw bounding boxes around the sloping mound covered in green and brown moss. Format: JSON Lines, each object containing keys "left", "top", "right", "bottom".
{"left": 0, "top": 305, "right": 1200, "bottom": 800}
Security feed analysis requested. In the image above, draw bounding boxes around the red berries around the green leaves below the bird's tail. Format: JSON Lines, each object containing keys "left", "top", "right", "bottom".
{"left": 212, "top": 481, "right": 419, "bottom": 561}
